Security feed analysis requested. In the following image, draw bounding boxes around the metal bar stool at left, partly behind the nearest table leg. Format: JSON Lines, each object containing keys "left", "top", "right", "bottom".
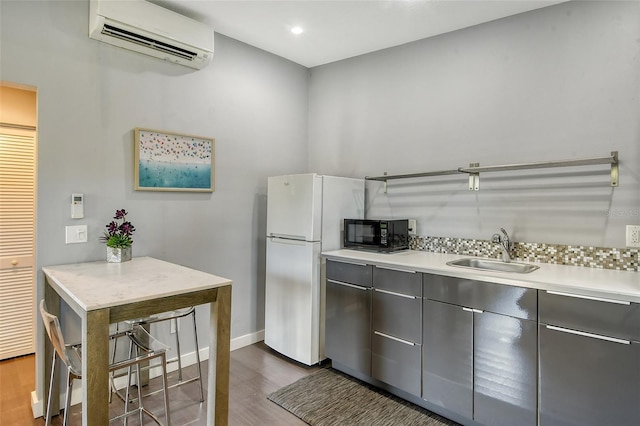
{"left": 40, "top": 300, "right": 171, "bottom": 426}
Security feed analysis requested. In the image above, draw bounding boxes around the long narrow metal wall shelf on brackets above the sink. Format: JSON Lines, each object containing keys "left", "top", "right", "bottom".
{"left": 365, "top": 151, "right": 618, "bottom": 193}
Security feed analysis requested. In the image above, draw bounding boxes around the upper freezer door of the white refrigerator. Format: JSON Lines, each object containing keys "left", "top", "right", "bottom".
{"left": 267, "top": 173, "right": 322, "bottom": 241}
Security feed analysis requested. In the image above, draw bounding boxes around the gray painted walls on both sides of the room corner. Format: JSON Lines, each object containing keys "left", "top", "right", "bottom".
{"left": 0, "top": 0, "right": 640, "bottom": 410}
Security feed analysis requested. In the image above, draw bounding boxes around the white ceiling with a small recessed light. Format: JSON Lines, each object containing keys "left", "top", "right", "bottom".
{"left": 158, "top": 0, "right": 566, "bottom": 68}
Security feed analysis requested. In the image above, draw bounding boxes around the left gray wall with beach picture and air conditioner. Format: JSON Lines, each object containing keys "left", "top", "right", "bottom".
{"left": 0, "top": 0, "right": 308, "bottom": 402}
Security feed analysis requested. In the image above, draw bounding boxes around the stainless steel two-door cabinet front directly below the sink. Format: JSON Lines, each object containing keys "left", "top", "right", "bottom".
{"left": 422, "top": 274, "right": 537, "bottom": 426}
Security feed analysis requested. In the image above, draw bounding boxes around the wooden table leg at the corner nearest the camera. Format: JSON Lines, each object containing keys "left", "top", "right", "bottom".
{"left": 82, "top": 309, "right": 109, "bottom": 426}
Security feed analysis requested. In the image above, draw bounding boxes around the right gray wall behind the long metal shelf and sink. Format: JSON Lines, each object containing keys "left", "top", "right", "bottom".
{"left": 309, "top": 1, "right": 640, "bottom": 247}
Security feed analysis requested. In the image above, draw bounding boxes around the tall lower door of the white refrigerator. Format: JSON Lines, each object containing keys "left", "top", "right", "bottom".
{"left": 264, "top": 238, "right": 320, "bottom": 365}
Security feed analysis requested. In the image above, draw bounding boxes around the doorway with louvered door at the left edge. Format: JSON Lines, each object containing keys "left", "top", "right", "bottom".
{"left": 0, "top": 83, "right": 37, "bottom": 360}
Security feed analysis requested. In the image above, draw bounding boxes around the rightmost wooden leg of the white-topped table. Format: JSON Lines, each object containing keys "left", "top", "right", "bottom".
{"left": 207, "top": 286, "right": 231, "bottom": 426}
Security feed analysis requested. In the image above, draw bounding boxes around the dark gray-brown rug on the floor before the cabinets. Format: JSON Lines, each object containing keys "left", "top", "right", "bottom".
{"left": 267, "top": 368, "right": 458, "bottom": 426}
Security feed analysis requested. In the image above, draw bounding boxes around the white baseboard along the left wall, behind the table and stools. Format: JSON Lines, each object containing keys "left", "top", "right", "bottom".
{"left": 31, "top": 329, "right": 264, "bottom": 419}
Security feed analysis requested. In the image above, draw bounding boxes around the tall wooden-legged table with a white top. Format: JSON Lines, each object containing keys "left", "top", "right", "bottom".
{"left": 41, "top": 257, "right": 232, "bottom": 426}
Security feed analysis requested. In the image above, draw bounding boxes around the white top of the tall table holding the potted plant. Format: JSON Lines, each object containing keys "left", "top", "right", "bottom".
{"left": 42, "top": 257, "right": 232, "bottom": 311}
